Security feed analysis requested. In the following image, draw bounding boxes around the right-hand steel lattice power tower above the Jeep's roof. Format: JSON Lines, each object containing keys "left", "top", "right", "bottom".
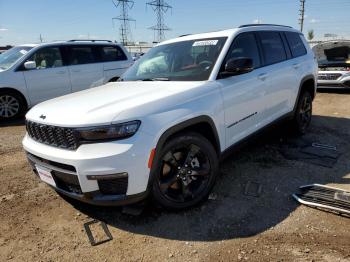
{"left": 146, "top": 0, "right": 172, "bottom": 42}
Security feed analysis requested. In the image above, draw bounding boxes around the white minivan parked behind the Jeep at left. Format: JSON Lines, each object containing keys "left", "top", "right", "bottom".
{"left": 0, "top": 40, "right": 133, "bottom": 119}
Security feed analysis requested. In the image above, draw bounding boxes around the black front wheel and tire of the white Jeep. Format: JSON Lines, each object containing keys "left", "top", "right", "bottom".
{"left": 152, "top": 133, "right": 219, "bottom": 210}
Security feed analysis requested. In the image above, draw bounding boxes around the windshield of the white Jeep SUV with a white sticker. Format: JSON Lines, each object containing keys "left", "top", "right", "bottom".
{"left": 120, "top": 37, "right": 227, "bottom": 81}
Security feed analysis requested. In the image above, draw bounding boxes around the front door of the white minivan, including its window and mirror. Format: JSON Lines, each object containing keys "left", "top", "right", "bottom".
{"left": 22, "top": 47, "right": 71, "bottom": 105}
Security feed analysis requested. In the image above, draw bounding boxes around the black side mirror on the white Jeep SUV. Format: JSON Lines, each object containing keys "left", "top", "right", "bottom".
{"left": 221, "top": 57, "right": 254, "bottom": 77}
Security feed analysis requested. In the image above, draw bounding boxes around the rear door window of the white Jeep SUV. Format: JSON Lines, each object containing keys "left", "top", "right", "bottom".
{"left": 259, "top": 32, "right": 287, "bottom": 65}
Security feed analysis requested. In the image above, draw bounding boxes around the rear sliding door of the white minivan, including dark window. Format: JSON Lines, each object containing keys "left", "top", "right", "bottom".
{"left": 66, "top": 45, "right": 104, "bottom": 92}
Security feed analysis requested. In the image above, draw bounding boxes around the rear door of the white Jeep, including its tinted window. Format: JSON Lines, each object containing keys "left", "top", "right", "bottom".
{"left": 258, "top": 31, "right": 297, "bottom": 122}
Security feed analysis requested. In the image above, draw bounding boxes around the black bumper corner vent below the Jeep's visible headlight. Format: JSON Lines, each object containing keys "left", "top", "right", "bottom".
{"left": 97, "top": 177, "right": 128, "bottom": 195}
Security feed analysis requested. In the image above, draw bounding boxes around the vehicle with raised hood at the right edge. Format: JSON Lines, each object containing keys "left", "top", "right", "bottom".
{"left": 313, "top": 40, "right": 350, "bottom": 88}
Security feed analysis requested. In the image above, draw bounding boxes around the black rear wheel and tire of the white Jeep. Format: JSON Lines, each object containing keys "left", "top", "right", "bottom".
{"left": 292, "top": 91, "right": 312, "bottom": 135}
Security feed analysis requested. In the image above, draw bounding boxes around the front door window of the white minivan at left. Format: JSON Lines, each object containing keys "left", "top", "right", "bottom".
{"left": 27, "top": 47, "right": 63, "bottom": 69}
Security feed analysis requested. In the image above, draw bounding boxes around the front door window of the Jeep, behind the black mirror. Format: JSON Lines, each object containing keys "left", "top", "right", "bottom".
{"left": 225, "top": 33, "right": 261, "bottom": 68}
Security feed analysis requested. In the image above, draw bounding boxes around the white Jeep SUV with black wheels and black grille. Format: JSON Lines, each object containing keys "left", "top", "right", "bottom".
{"left": 23, "top": 25, "right": 317, "bottom": 209}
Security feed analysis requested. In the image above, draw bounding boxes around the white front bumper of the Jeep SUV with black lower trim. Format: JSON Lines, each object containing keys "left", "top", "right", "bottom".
{"left": 23, "top": 132, "right": 152, "bottom": 206}
